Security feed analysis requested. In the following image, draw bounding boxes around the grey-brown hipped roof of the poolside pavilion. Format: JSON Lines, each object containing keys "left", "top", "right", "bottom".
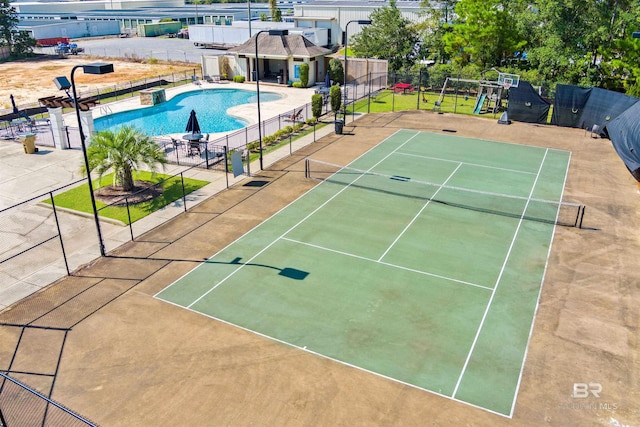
{"left": 229, "top": 34, "right": 331, "bottom": 58}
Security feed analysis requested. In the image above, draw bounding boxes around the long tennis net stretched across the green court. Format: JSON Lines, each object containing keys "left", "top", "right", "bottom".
{"left": 305, "top": 158, "right": 585, "bottom": 228}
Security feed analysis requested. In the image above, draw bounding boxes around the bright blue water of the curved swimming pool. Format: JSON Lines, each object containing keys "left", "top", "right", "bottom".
{"left": 94, "top": 89, "right": 281, "bottom": 136}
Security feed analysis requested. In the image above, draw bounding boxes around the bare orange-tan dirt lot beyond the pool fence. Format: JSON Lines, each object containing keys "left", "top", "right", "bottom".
{"left": 0, "top": 56, "right": 200, "bottom": 109}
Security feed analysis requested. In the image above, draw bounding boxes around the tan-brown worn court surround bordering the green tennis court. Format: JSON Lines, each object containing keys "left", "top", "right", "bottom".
{"left": 0, "top": 111, "right": 640, "bottom": 426}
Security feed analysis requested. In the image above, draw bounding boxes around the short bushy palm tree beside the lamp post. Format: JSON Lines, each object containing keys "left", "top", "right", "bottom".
{"left": 82, "top": 126, "right": 167, "bottom": 191}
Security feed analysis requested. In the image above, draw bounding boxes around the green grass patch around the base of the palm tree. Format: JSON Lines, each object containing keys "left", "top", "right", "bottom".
{"left": 43, "top": 171, "right": 209, "bottom": 224}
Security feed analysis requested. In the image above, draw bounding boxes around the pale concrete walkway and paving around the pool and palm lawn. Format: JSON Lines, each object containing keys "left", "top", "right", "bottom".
{"left": 0, "top": 84, "right": 334, "bottom": 310}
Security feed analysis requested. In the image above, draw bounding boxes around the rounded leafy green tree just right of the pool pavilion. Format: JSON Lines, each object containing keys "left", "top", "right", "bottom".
{"left": 350, "top": 0, "right": 420, "bottom": 71}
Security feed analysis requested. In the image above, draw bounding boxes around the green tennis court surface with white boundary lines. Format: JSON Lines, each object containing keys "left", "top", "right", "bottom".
{"left": 157, "top": 130, "right": 575, "bottom": 416}
